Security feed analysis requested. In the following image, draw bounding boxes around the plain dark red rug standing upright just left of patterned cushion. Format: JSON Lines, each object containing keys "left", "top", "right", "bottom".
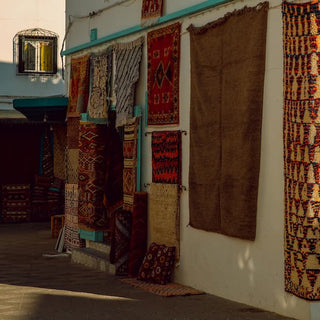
{"left": 128, "top": 192, "right": 148, "bottom": 277}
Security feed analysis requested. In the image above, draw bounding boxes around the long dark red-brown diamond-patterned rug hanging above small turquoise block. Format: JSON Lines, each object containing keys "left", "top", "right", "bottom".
{"left": 78, "top": 121, "right": 107, "bottom": 231}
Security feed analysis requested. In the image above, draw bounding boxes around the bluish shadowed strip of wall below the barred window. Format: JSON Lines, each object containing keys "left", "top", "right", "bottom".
{"left": 0, "top": 62, "right": 65, "bottom": 96}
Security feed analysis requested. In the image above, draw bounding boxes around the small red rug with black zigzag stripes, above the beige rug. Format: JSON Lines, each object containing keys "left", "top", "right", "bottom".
{"left": 151, "top": 131, "right": 181, "bottom": 184}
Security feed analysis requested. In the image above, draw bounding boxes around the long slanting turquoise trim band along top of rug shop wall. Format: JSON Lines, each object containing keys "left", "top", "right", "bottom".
{"left": 61, "top": 0, "right": 232, "bottom": 56}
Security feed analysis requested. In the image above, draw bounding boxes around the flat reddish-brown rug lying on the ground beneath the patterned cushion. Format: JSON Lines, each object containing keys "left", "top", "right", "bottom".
{"left": 119, "top": 278, "right": 204, "bottom": 297}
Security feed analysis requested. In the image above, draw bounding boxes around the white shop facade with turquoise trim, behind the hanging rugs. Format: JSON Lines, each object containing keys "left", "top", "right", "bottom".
{"left": 63, "top": 0, "right": 320, "bottom": 319}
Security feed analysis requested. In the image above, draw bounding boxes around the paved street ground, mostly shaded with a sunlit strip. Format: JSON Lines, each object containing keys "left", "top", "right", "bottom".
{"left": 0, "top": 223, "right": 296, "bottom": 320}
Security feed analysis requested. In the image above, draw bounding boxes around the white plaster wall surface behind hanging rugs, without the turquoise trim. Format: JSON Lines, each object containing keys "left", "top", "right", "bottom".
{"left": 67, "top": 0, "right": 319, "bottom": 319}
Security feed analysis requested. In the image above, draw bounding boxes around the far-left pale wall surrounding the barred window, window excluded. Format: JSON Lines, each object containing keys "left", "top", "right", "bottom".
{"left": 0, "top": 0, "right": 65, "bottom": 110}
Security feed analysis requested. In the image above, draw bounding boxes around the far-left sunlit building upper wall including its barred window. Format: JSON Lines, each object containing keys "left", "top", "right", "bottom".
{"left": 0, "top": 0, "right": 65, "bottom": 110}
